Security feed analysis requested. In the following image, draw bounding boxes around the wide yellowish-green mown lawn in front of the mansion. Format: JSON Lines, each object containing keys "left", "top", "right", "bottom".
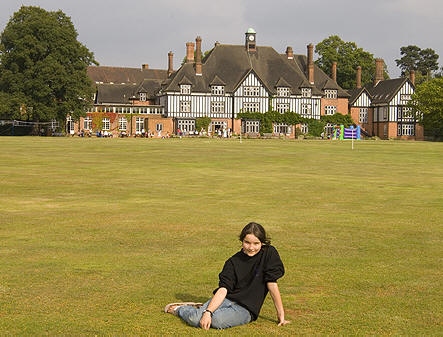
{"left": 0, "top": 137, "right": 443, "bottom": 336}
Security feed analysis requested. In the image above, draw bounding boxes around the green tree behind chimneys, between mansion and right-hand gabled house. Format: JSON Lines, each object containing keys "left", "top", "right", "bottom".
{"left": 315, "top": 35, "right": 387, "bottom": 89}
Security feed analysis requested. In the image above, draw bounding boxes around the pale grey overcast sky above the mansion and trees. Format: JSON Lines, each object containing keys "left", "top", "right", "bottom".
{"left": 0, "top": 0, "right": 443, "bottom": 78}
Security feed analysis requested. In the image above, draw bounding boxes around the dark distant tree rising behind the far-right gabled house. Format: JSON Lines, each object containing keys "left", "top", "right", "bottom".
{"left": 395, "top": 45, "right": 439, "bottom": 79}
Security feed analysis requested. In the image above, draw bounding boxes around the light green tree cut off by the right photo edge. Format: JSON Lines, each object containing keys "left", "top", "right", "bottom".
{"left": 409, "top": 77, "right": 443, "bottom": 138}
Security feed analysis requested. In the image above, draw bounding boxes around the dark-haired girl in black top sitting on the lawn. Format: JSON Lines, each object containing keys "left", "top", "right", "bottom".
{"left": 165, "top": 222, "right": 289, "bottom": 330}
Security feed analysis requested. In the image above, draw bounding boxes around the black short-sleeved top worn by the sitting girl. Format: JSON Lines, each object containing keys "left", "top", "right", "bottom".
{"left": 214, "top": 246, "right": 285, "bottom": 321}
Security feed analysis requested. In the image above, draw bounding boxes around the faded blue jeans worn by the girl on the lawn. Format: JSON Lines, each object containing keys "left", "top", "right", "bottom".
{"left": 177, "top": 298, "right": 252, "bottom": 329}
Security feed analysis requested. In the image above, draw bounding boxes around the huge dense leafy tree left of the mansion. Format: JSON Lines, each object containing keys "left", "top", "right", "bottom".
{"left": 0, "top": 6, "right": 97, "bottom": 121}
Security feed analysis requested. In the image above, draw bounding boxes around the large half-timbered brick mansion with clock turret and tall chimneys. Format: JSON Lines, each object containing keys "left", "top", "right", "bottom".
{"left": 68, "top": 29, "right": 350, "bottom": 137}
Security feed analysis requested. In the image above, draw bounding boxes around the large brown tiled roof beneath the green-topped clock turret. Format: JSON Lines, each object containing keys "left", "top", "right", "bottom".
{"left": 162, "top": 44, "right": 349, "bottom": 97}
